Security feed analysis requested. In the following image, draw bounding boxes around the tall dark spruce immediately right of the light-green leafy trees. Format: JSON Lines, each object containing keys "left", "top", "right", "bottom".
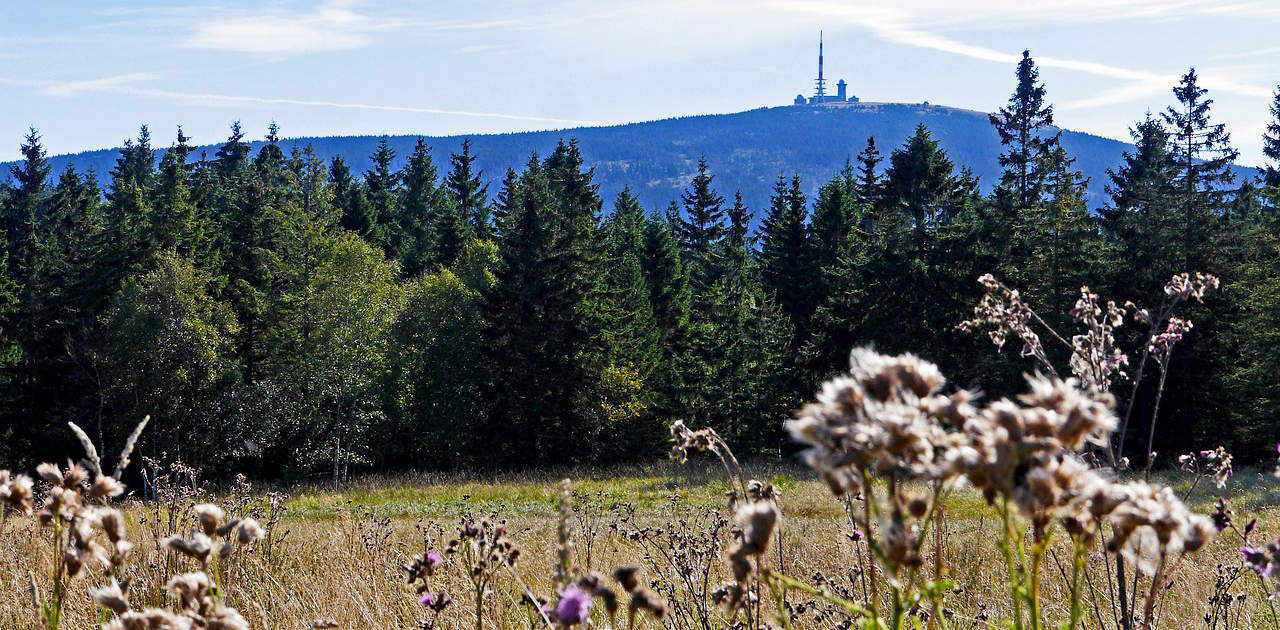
{"left": 484, "top": 153, "right": 600, "bottom": 464}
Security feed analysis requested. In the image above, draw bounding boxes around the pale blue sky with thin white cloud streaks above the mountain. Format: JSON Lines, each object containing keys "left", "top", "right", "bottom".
{"left": 0, "top": 0, "right": 1280, "bottom": 165}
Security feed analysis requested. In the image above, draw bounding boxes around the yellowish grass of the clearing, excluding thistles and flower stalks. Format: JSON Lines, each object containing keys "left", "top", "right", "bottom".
{"left": 0, "top": 464, "right": 1280, "bottom": 629}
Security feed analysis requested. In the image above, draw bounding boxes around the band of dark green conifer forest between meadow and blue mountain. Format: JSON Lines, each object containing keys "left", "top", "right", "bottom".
{"left": 0, "top": 55, "right": 1280, "bottom": 479}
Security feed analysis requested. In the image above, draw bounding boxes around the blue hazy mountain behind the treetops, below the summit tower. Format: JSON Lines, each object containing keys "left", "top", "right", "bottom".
{"left": 0, "top": 102, "right": 1252, "bottom": 215}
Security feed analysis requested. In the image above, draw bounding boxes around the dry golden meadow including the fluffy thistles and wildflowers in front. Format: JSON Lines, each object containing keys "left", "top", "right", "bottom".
{"left": 0, "top": 273, "right": 1280, "bottom": 630}
